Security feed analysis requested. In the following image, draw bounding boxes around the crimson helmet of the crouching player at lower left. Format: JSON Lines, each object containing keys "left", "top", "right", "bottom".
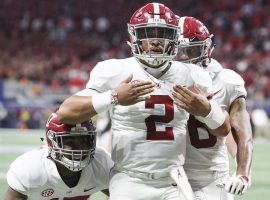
{"left": 46, "top": 113, "right": 96, "bottom": 171}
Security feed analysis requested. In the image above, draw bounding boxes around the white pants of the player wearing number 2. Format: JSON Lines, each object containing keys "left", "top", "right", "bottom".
{"left": 109, "top": 170, "right": 188, "bottom": 200}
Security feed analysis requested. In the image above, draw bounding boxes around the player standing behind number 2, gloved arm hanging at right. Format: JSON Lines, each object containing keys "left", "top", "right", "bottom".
{"left": 176, "top": 17, "right": 253, "bottom": 200}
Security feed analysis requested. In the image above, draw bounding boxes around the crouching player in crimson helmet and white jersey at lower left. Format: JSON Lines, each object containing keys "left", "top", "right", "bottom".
{"left": 4, "top": 113, "right": 113, "bottom": 200}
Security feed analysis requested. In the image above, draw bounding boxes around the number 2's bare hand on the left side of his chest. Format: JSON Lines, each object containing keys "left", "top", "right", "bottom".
{"left": 115, "top": 74, "right": 155, "bottom": 106}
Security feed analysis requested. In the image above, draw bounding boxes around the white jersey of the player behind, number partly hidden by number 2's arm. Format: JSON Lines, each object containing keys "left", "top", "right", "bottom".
{"left": 184, "top": 59, "right": 247, "bottom": 180}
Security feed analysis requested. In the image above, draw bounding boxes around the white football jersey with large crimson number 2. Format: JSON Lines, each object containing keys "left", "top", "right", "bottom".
{"left": 87, "top": 57, "right": 212, "bottom": 173}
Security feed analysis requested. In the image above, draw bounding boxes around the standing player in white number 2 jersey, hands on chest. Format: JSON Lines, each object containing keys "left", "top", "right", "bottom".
{"left": 59, "top": 3, "right": 229, "bottom": 200}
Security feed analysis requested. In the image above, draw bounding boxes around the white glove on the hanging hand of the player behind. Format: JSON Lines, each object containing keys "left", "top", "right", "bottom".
{"left": 217, "top": 175, "right": 249, "bottom": 195}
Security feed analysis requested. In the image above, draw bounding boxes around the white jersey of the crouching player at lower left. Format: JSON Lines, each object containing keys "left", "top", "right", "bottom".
{"left": 7, "top": 146, "right": 113, "bottom": 200}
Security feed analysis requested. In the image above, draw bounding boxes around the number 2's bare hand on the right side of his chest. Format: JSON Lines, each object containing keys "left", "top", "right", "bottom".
{"left": 172, "top": 85, "right": 211, "bottom": 117}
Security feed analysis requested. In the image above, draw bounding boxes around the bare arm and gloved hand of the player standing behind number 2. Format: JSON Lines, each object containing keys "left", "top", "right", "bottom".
{"left": 221, "top": 97, "right": 253, "bottom": 195}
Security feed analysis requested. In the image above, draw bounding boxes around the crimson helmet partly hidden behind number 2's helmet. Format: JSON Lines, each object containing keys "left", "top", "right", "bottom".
{"left": 177, "top": 17, "right": 214, "bottom": 67}
